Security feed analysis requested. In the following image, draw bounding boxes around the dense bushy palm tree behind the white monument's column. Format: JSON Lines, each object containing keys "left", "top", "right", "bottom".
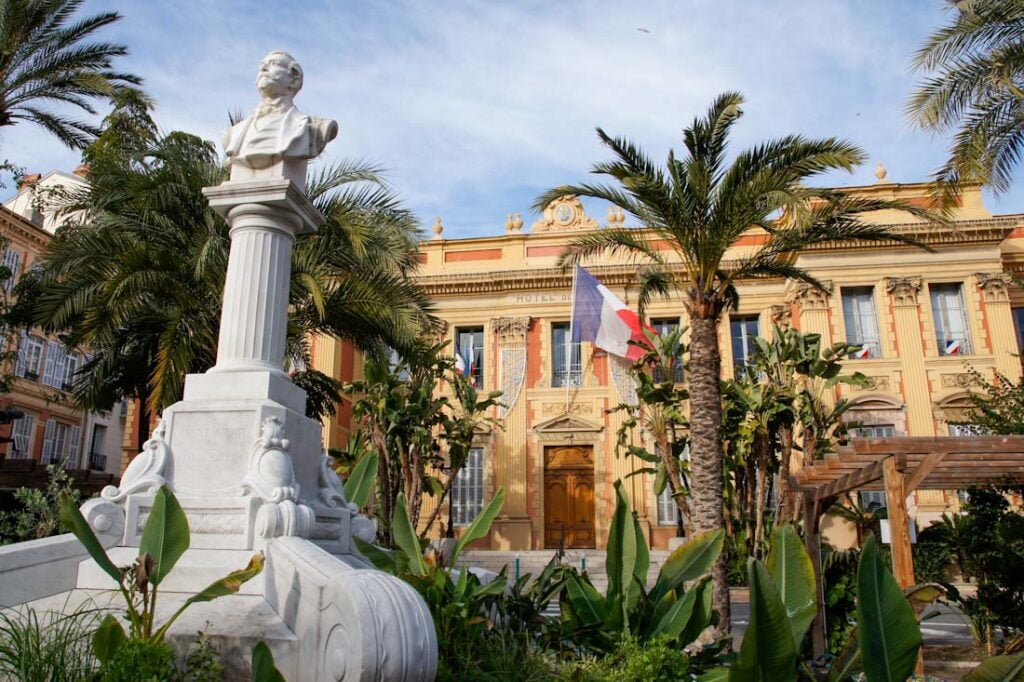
{"left": 22, "top": 97, "right": 427, "bottom": 446}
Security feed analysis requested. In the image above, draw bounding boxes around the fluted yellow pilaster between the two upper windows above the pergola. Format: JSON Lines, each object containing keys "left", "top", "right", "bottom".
{"left": 886, "top": 276, "right": 935, "bottom": 436}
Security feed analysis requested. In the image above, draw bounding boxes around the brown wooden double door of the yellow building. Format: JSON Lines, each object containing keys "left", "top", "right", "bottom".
{"left": 544, "top": 446, "right": 596, "bottom": 549}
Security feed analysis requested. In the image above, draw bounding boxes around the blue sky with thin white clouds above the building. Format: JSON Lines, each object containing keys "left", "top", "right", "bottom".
{"left": 0, "top": 0, "right": 1024, "bottom": 238}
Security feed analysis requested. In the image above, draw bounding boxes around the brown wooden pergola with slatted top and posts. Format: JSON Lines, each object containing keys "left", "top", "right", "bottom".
{"left": 788, "top": 436, "right": 1024, "bottom": 656}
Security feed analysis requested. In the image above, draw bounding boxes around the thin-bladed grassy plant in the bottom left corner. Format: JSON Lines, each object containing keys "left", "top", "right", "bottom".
{"left": 0, "top": 606, "right": 99, "bottom": 682}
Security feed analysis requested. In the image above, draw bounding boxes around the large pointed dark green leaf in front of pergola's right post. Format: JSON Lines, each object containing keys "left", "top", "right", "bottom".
{"left": 857, "top": 536, "right": 922, "bottom": 682}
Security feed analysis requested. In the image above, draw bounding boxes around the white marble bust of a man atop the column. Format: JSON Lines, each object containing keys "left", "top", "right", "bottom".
{"left": 222, "top": 50, "right": 338, "bottom": 188}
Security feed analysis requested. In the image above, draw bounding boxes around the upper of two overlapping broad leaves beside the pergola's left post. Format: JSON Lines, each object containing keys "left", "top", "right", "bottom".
{"left": 767, "top": 523, "right": 817, "bottom": 645}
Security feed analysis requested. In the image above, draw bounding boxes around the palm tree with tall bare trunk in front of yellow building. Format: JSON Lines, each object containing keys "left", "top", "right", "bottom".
{"left": 535, "top": 92, "right": 932, "bottom": 633}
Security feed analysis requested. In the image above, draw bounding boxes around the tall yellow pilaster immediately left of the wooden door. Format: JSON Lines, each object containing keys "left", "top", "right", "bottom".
{"left": 490, "top": 316, "right": 532, "bottom": 550}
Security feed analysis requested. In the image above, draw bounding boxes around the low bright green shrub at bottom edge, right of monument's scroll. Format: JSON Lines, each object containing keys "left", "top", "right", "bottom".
{"left": 559, "top": 636, "right": 690, "bottom": 682}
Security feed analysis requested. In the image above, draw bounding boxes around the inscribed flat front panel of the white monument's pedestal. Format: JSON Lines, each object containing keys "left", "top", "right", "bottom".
{"left": 170, "top": 410, "right": 256, "bottom": 495}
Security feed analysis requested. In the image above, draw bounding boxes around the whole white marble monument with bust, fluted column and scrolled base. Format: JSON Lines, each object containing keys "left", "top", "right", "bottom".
{"left": 0, "top": 51, "right": 437, "bottom": 681}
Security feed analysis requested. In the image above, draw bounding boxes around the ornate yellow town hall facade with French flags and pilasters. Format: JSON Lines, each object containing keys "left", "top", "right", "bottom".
{"left": 314, "top": 175, "right": 1024, "bottom": 550}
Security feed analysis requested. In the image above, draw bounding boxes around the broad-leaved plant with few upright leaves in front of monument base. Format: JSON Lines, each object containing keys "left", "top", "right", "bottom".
{"left": 60, "top": 486, "right": 263, "bottom": 670}
